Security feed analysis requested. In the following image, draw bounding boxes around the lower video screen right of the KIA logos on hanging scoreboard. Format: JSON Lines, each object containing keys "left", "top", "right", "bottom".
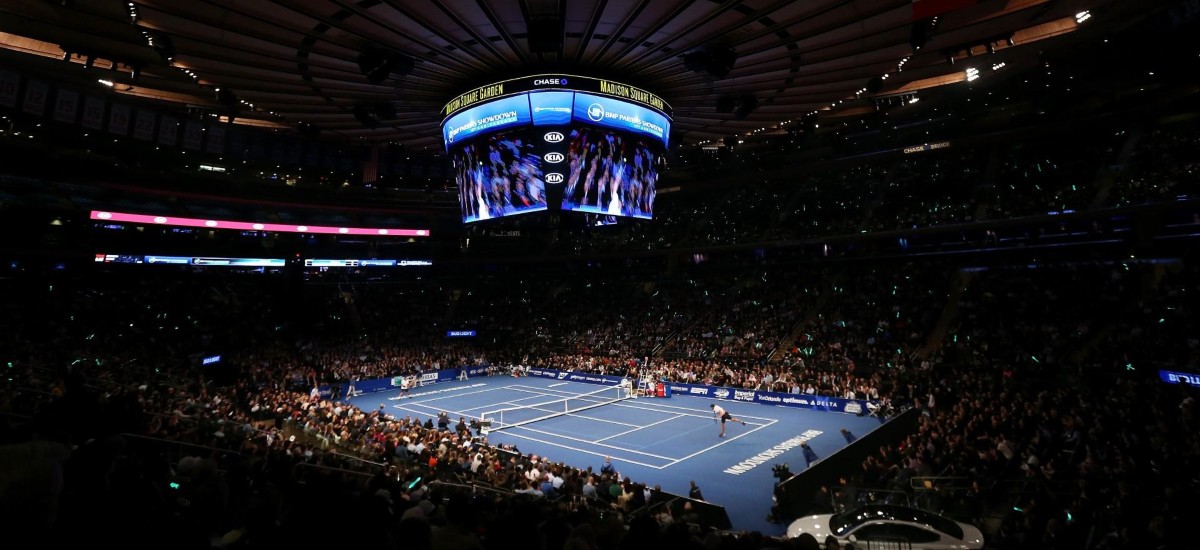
{"left": 563, "top": 127, "right": 659, "bottom": 220}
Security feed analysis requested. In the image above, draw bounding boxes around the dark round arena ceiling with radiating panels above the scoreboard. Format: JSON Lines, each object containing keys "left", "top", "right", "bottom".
{"left": 0, "top": 0, "right": 1180, "bottom": 150}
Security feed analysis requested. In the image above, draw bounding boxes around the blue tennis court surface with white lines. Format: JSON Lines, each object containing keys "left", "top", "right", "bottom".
{"left": 350, "top": 376, "right": 880, "bottom": 536}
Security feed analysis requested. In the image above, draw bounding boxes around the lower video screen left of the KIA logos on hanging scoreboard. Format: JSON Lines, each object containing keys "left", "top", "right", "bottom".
{"left": 452, "top": 132, "right": 546, "bottom": 223}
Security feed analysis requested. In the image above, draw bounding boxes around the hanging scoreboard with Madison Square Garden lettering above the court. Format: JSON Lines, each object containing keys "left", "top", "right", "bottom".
{"left": 442, "top": 74, "right": 671, "bottom": 223}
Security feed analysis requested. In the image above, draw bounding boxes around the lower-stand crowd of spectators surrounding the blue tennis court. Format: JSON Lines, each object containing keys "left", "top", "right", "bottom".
{"left": 4, "top": 250, "right": 1200, "bottom": 548}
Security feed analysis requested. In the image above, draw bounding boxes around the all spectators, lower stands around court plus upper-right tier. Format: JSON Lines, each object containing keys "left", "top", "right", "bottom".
{"left": 0, "top": 119, "right": 1200, "bottom": 549}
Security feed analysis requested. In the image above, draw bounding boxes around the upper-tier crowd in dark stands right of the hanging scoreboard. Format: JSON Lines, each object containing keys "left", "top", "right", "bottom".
{"left": 535, "top": 125, "right": 1196, "bottom": 260}
